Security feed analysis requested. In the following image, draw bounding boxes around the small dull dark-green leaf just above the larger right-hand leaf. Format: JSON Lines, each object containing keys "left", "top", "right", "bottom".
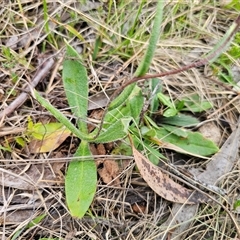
{"left": 158, "top": 113, "right": 199, "bottom": 127}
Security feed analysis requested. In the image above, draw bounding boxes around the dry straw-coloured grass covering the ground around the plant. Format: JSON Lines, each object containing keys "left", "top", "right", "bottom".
{"left": 0, "top": 0, "right": 240, "bottom": 240}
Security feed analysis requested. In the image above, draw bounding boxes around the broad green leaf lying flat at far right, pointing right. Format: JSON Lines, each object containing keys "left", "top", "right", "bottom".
{"left": 156, "top": 128, "right": 219, "bottom": 156}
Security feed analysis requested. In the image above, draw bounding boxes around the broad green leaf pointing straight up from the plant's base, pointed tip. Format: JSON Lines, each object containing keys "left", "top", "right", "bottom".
{"left": 62, "top": 45, "right": 88, "bottom": 133}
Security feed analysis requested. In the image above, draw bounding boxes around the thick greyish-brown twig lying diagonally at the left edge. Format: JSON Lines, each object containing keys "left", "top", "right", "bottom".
{"left": 0, "top": 58, "right": 54, "bottom": 119}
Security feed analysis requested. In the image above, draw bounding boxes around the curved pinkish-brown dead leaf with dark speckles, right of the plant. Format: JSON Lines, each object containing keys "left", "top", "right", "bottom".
{"left": 132, "top": 144, "right": 208, "bottom": 204}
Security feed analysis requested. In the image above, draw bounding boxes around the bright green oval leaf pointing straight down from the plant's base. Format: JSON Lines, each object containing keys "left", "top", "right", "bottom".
{"left": 65, "top": 140, "right": 97, "bottom": 218}
